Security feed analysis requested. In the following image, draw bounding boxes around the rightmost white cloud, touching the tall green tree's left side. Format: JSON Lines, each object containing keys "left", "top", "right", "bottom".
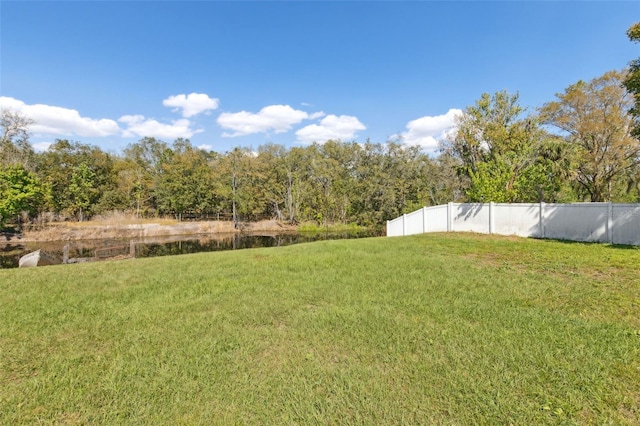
{"left": 400, "top": 108, "right": 462, "bottom": 150}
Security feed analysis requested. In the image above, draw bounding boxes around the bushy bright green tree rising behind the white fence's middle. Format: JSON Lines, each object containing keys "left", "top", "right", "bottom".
{"left": 444, "top": 91, "right": 555, "bottom": 202}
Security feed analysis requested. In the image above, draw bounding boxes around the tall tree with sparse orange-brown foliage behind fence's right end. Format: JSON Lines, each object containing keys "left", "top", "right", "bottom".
{"left": 540, "top": 71, "right": 640, "bottom": 201}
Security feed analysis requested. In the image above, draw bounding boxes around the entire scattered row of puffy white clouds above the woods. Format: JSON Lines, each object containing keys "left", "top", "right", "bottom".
{"left": 0, "top": 93, "right": 462, "bottom": 151}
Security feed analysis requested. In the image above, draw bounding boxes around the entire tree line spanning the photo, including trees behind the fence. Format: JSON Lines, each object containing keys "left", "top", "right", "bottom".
{"left": 0, "top": 23, "right": 640, "bottom": 230}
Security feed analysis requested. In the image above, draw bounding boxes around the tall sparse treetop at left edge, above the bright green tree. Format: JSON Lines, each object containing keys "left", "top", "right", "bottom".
{"left": 0, "top": 109, "right": 35, "bottom": 170}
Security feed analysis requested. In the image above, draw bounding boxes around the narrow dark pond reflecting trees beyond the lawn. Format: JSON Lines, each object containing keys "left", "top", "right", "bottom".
{"left": 0, "top": 231, "right": 379, "bottom": 269}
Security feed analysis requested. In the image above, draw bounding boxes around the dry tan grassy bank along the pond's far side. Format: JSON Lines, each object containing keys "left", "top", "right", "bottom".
{"left": 11, "top": 220, "right": 296, "bottom": 242}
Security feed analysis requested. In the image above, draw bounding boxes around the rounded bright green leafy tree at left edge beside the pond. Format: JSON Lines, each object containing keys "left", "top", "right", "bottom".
{"left": 0, "top": 165, "right": 46, "bottom": 226}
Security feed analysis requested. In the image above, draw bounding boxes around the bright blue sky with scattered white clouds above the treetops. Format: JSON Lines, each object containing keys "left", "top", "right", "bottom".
{"left": 0, "top": 0, "right": 640, "bottom": 153}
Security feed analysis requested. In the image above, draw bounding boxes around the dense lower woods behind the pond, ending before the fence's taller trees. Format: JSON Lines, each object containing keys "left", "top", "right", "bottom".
{"left": 0, "top": 134, "right": 449, "bottom": 228}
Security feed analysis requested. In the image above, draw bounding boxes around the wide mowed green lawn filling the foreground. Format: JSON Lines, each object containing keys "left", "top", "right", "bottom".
{"left": 0, "top": 234, "right": 640, "bottom": 425}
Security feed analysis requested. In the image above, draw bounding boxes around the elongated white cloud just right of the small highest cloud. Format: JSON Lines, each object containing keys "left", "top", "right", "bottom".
{"left": 218, "top": 105, "right": 324, "bottom": 137}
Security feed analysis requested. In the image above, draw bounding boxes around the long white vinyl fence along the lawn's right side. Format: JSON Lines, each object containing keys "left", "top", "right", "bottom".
{"left": 387, "top": 203, "right": 640, "bottom": 245}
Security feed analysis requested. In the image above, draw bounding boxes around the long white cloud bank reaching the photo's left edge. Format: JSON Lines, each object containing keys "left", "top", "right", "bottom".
{"left": 0, "top": 96, "right": 120, "bottom": 137}
